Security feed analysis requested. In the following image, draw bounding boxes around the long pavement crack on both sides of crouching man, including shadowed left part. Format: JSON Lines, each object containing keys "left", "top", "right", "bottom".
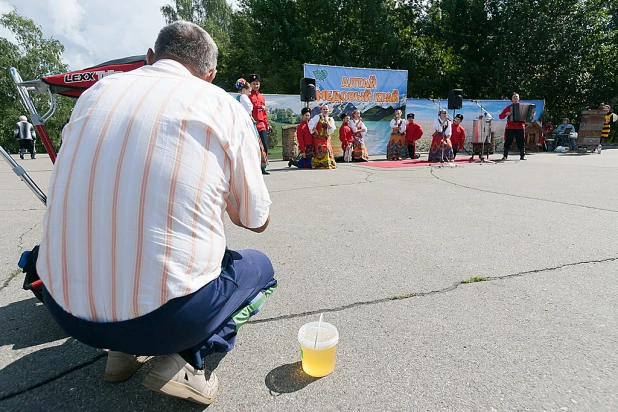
{"left": 0, "top": 256, "right": 618, "bottom": 401}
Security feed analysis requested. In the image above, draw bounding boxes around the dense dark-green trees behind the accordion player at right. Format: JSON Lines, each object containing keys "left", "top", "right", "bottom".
{"left": 416, "top": 0, "right": 618, "bottom": 125}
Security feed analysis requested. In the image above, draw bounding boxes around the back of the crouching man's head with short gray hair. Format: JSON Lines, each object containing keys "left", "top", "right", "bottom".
{"left": 154, "top": 20, "right": 218, "bottom": 76}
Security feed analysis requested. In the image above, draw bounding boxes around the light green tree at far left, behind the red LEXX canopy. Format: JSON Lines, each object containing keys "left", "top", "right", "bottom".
{"left": 0, "top": 10, "right": 74, "bottom": 152}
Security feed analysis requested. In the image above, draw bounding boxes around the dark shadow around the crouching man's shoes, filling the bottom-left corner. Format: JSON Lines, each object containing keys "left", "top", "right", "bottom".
{"left": 0, "top": 346, "right": 207, "bottom": 411}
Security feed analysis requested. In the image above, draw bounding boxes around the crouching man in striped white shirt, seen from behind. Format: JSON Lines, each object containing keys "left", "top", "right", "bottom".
{"left": 36, "top": 21, "right": 277, "bottom": 404}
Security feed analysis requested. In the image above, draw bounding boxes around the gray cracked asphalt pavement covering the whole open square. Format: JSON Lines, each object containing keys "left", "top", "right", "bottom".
{"left": 0, "top": 150, "right": 618, "bottom": 411}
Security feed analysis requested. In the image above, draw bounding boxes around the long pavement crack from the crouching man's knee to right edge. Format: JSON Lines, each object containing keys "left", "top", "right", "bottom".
{"left": 247, "top": 257, "right": 618, "bottom": 325}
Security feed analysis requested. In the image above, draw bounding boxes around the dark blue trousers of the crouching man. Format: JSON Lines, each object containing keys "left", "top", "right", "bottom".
{"left": 43, "top": 250, "right": 277, "bottom": 369}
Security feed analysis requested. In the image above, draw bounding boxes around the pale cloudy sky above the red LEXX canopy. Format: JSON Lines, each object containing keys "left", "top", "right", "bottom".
{"left": 0, "top": 0, "right": 172, "bottom": 70}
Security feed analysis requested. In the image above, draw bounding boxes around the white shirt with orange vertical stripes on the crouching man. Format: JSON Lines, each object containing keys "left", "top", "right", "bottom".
{"left": 37, "top": 60, "right": 271, "bottom": 322}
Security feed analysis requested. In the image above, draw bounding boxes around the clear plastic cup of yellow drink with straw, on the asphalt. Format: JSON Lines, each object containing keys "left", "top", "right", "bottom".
{"left": 298, "top": 322, "right": 339, "bottom": 378}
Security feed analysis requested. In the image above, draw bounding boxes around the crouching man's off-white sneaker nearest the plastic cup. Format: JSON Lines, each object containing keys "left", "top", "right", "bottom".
{"left": 144, "top": 353, "right": 219, "bottom": 405}
